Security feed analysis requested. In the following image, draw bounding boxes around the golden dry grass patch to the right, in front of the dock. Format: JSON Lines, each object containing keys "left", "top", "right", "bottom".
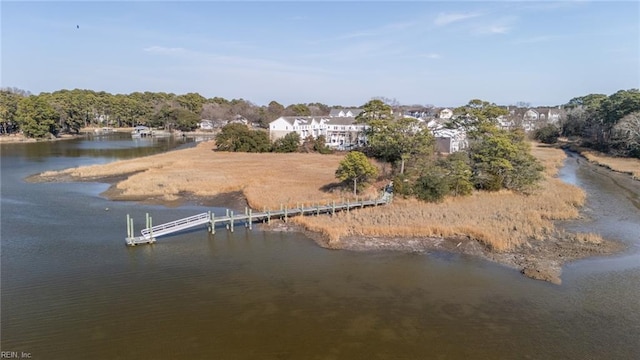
{"left": 293, "top": 145, "right": 597, "bottom": 251}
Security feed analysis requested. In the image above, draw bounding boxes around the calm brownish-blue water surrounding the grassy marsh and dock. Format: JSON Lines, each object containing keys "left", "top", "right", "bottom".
{"left": 0, "top": 138, "right": 640, "bottom": 359}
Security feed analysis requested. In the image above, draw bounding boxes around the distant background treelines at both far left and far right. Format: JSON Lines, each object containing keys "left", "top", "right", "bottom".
{"left": 0, "top": 88, "right": 640, "bottom": 158}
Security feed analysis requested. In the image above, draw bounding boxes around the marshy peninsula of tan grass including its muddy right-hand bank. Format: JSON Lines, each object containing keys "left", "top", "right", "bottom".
{"left": 28, "top": 141, "right": 623, "bottom": 284}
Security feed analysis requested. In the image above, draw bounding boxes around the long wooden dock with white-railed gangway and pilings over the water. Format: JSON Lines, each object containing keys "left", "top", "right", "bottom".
{"left": 125, "top": 193, "right": 391, "bottom": 246}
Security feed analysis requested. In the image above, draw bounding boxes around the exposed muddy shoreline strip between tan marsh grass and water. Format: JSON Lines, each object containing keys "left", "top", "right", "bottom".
{"left": 36, "top": 162, "right": 628, "bottom": 285}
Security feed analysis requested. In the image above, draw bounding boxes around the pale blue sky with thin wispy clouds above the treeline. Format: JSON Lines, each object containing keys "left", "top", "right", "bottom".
{"left": 0, "top": 0, "right": 640, "bottom": 106}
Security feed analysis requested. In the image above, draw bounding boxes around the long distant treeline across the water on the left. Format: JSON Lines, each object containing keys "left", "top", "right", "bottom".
{"left": 0, "top": 88, "right": 330, "bottom": 137}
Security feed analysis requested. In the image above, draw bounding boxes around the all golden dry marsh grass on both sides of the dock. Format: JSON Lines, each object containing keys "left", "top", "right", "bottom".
{"left": 43, "top": 142, "right": 601, "bottom": 251}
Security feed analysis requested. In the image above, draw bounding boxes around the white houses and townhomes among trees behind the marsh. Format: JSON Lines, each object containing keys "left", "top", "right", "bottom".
{"left": 269, "top": 107, "right": 564, "bottom": 153}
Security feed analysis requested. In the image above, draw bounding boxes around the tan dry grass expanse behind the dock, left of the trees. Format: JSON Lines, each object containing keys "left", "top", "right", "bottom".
{"left": 43, "top": 142, "right": 364, "bottom": 209}
